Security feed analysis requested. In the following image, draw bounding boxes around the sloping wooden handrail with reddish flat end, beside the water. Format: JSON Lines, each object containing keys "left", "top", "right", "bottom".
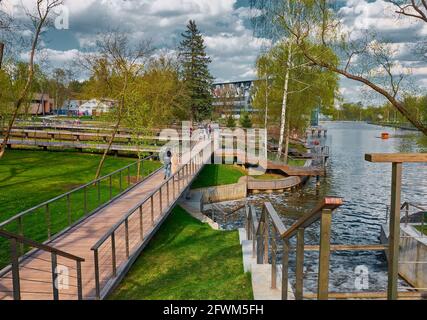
{"left": 281, "top": 197, "right": 343, "bottom": 239}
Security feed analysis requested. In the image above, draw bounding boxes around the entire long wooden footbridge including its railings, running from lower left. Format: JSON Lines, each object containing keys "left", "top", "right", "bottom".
{"left": 0, "top": 140, "right": 212, "bottom": 300}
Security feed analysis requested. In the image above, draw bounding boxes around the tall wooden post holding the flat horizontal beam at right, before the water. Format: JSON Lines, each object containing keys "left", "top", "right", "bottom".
{"left": 388, "top": 163, "right": 403, "bottom": 300}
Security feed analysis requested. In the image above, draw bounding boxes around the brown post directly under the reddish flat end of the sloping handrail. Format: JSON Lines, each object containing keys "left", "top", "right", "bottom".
{"left": 317, "top": 209, "right": 332, "bottom": 300}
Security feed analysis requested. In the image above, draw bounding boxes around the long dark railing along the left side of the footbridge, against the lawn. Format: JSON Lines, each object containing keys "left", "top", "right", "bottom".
{"left": 0, "top": 156, "right": 158, "bottom": 267}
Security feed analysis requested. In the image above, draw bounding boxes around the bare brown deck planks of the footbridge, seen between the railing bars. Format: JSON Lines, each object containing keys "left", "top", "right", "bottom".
{"left": 0, "top": 142, "right": 209, "bottom": 300}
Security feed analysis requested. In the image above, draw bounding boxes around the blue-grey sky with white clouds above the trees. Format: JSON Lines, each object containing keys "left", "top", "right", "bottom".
{"left": 3, "top": 0, "right": 427, "bottom": 101}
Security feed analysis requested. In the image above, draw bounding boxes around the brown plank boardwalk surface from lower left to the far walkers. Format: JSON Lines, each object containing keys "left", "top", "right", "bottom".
{"left": 0, "top": 142, "right": 210, "bottom": 300}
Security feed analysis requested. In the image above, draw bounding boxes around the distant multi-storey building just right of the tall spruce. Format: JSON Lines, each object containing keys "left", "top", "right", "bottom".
{"left": 212, "top": 81, "right": 255, "bottom": 118}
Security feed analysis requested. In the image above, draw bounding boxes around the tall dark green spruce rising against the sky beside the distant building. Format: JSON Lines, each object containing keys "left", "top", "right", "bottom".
{"left": 179, "top": 20, "right": 213, "bottom": 121}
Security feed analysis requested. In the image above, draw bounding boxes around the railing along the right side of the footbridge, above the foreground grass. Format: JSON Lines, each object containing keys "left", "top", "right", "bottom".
{"left": 91, "top": 141, "right": 210, "bottom": 299}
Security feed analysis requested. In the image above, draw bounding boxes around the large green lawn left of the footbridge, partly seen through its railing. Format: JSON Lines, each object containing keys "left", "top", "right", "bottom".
{"left": 0, "top": 150, "right": 160, "bottom": 267}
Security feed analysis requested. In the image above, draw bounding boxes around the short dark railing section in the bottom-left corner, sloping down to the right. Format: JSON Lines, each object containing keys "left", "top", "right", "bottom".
{"left": 0, "top": 230, "right": 85, "bottom": 300}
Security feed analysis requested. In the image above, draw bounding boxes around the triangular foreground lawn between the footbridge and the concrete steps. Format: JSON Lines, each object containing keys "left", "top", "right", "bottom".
{"left": 109, "top": 207, "right": 253, "bottom": 300}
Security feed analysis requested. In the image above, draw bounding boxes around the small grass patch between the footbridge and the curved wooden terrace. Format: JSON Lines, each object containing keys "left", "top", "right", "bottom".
{"left": 191, "top": 164, "right": 246, "bottom": 189}
